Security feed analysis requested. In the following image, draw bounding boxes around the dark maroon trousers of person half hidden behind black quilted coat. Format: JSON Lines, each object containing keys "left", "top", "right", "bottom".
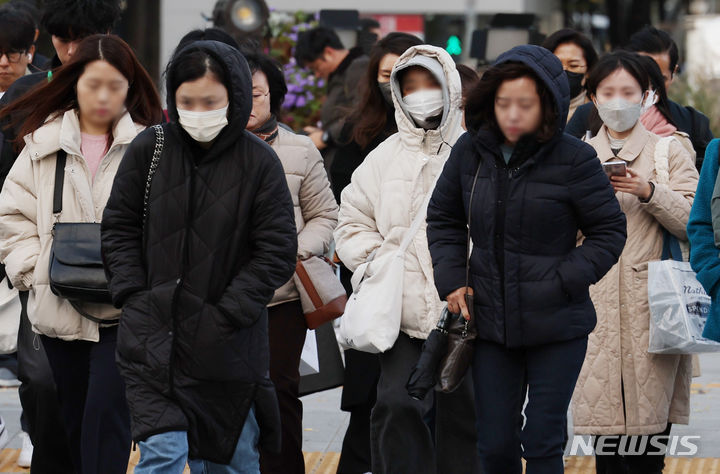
{"left": 260, "top": 301, "right": 307, "bottom": 474}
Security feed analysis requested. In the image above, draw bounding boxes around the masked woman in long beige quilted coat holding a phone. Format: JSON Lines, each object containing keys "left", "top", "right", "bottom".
{"left": 573, "top": 52, "right": 698, "bottom": 473}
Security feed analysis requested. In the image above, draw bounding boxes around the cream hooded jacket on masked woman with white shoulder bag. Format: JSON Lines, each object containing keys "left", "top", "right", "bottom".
{"left": 335, "top": 45, "right": 463, "bottom": 339}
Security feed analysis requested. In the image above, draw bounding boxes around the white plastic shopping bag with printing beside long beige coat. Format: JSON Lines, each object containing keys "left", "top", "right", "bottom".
{"left": 648, "top": 260, "right": 720, "bottom": 354}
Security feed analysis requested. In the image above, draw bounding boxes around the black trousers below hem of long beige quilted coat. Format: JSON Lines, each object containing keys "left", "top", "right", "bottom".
{"left": 594, "top": 423, "right": 672, "bottom": 474}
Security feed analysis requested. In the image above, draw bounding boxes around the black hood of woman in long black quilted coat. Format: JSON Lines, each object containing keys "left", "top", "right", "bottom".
{"left": 165, "top": 41, "right": 252, "bottom": 130}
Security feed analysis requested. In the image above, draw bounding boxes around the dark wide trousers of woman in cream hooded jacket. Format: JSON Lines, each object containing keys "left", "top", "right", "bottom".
{"left": 370, "top": 332, "right": 478, "bottom": 474}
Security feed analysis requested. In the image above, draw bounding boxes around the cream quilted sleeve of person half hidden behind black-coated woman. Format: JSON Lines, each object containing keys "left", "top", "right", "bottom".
{"left": 298, "top": 141, "right": 338, "bottom": 260}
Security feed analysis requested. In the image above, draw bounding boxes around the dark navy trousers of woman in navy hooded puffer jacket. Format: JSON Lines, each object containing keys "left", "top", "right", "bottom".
{"left": 473, "top": 337, "right": 587, "bottom": 474}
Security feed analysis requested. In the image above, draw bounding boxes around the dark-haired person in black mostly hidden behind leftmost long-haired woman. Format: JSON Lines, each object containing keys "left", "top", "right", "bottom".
{"left": 0, "top": 0, "right": 120, "bottom": 474}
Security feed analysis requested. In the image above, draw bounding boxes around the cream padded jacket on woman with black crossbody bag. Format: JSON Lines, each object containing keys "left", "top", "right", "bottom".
{"left": 0, "top": 110, "right": 145, "bottom": 342}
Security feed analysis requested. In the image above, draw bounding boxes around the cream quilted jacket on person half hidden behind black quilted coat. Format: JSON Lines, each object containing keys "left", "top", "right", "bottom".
{"left": 270, "top": 127, "right": 338, "bottom": 306}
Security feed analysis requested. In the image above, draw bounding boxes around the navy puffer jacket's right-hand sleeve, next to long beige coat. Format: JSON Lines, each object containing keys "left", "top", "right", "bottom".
{"left": 557, "top": 143, "right": 627, "bottom": 298}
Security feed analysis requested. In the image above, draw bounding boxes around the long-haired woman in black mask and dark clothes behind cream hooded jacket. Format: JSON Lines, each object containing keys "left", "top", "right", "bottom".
{"left": 330, "top": 33, "right": 422, "bottom": 474}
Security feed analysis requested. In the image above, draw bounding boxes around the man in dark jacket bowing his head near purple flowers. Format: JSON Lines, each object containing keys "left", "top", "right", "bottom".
{"left": 295, "top": 26, "right": 369, "bottom": 170}
